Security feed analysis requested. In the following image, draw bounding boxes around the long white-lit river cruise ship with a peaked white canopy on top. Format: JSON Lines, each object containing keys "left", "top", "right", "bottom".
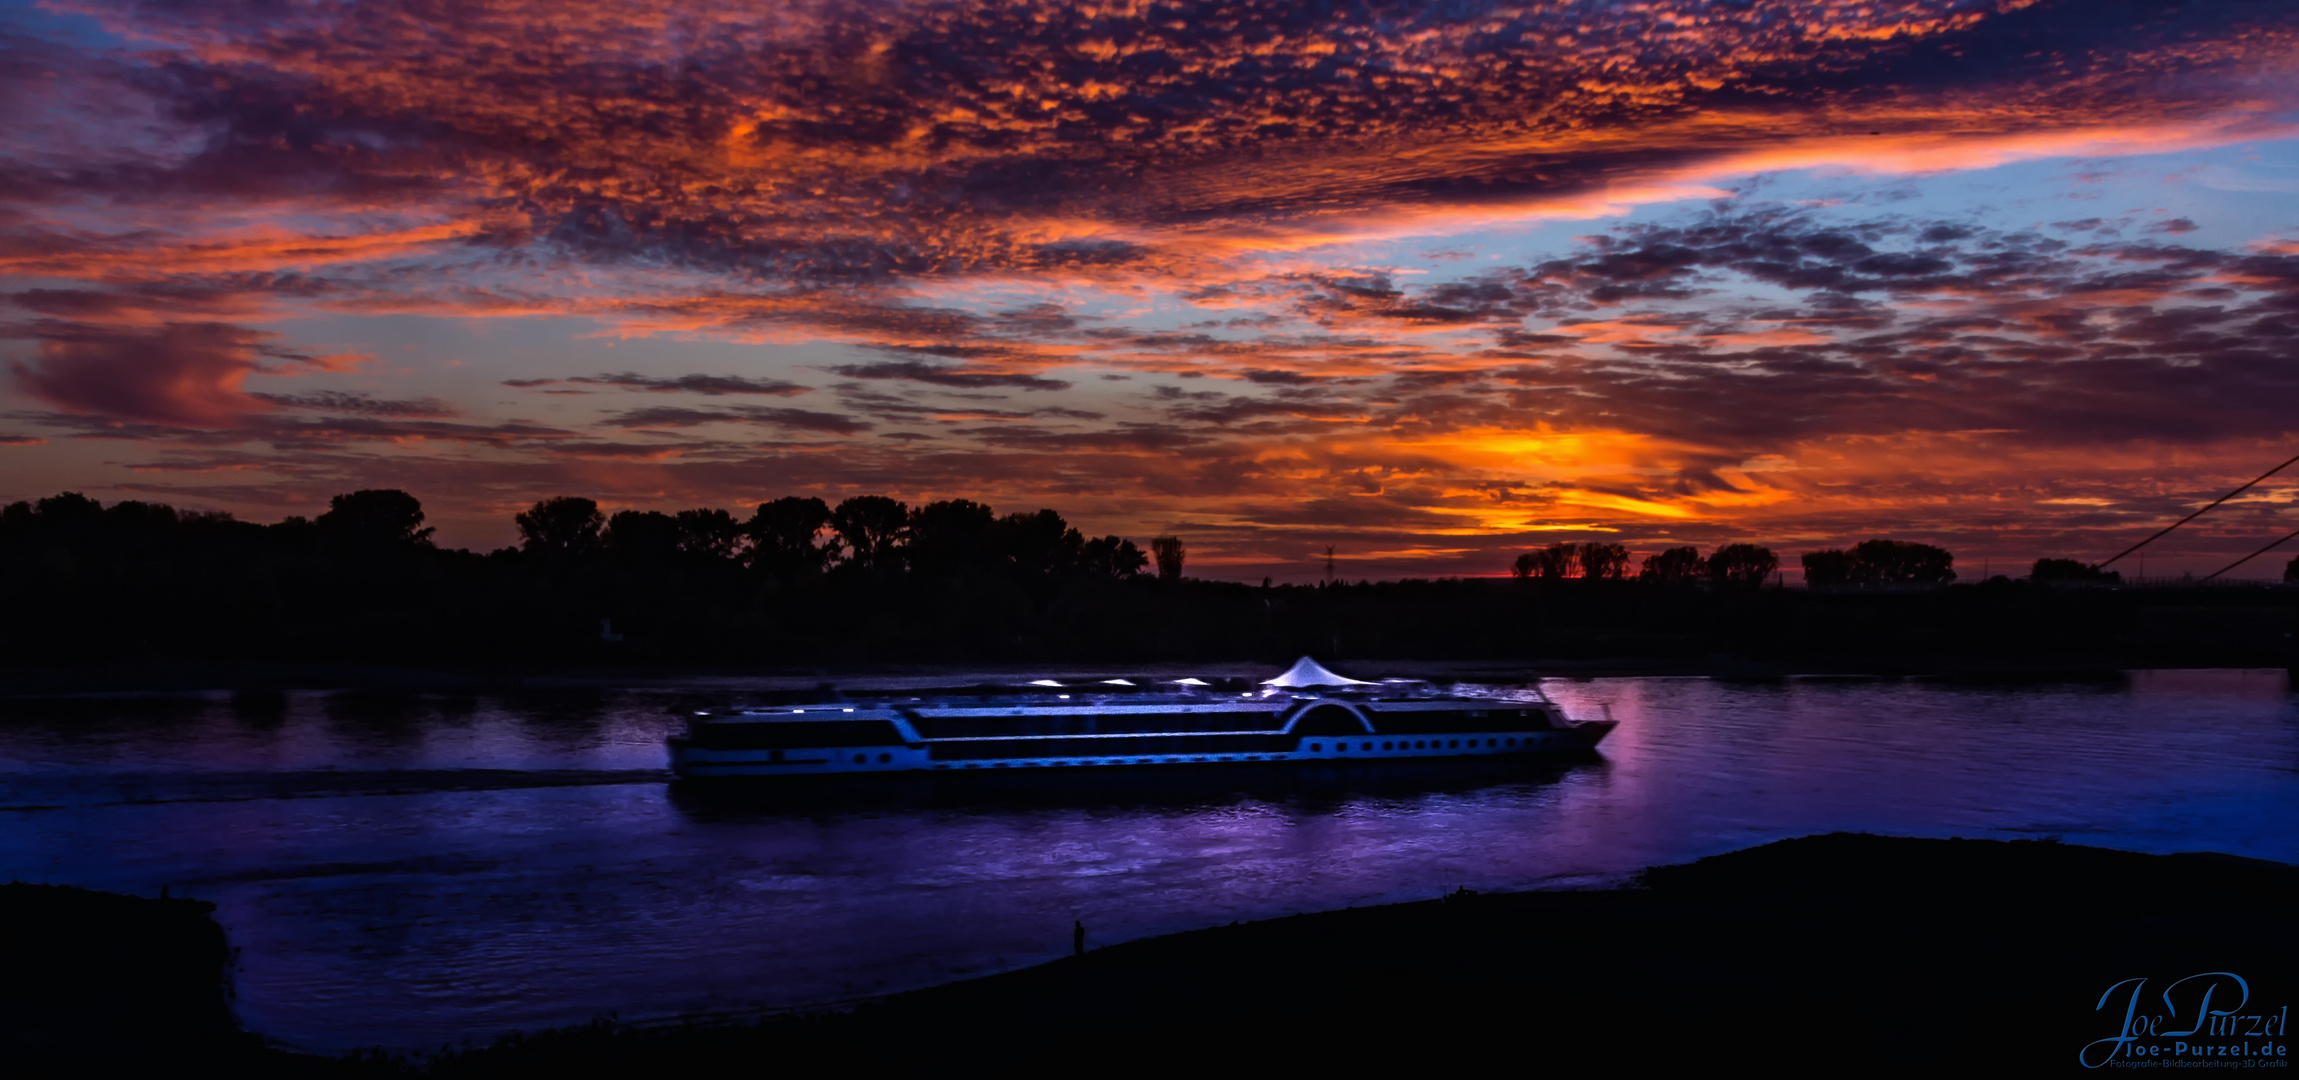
{"left": 671, "top": 657, "right": 1614, "bottom": 779}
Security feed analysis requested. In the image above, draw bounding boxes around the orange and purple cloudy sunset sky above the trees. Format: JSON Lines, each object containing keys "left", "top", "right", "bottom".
{"left": 0, "top": 0, "right": 2299, "bottom": 581}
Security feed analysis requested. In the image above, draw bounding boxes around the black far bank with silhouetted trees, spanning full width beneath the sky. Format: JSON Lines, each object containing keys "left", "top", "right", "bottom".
{"left": 0, "top": 489, "right": 2299, "bottom": 666}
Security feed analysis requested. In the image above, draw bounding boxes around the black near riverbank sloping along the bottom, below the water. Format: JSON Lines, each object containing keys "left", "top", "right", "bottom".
{"left": 5, "top": 834, "right": 2299, "bottom": 1075}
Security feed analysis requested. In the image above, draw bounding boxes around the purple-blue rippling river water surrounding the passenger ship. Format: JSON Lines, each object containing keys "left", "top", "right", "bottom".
{"left": 0, "top": 671, "right": 2299, "bottom": 1052}
